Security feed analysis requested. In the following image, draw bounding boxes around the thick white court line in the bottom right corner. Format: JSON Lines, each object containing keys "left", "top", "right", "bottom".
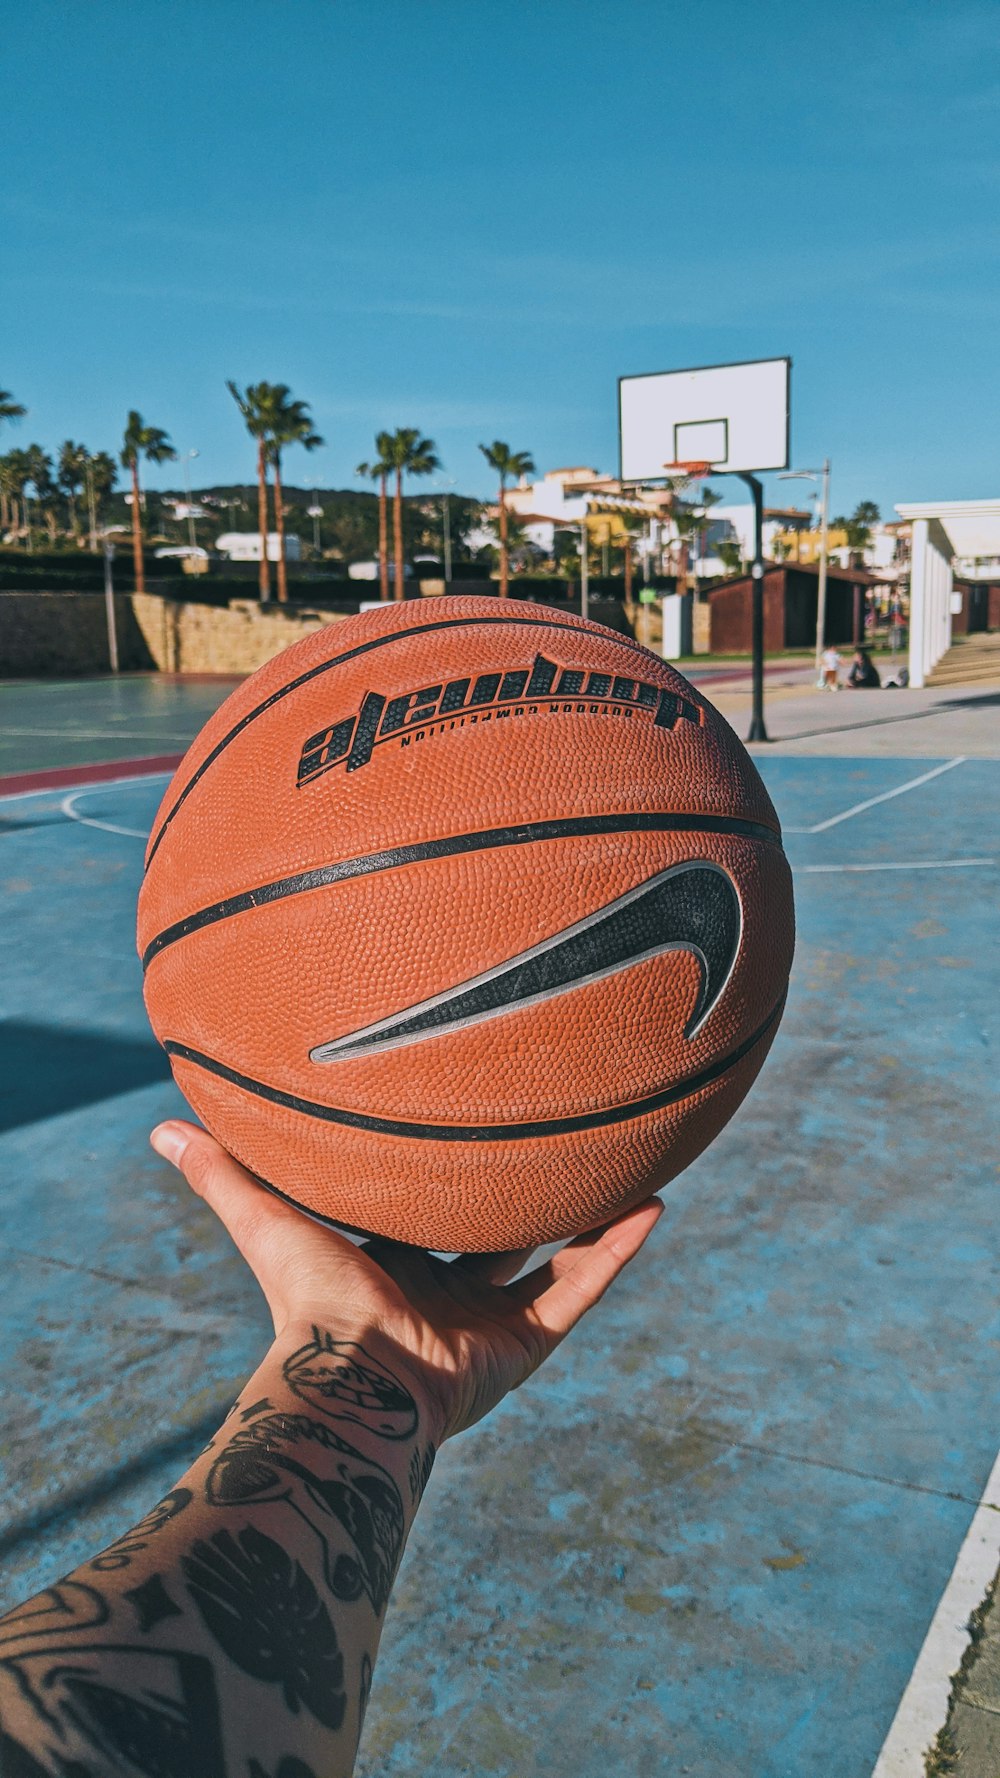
{"left": 872, "top": 1456, "right": 1000, "bottom": 1778}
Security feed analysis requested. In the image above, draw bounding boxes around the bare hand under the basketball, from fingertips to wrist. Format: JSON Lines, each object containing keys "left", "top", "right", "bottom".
{"left": 151, "top": 1122, "right": 662, "bottom": 1442}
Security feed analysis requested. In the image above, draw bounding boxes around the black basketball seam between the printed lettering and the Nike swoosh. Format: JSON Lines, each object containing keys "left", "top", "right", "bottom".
{"left": 142, "top": 813, "right": 781, "bottom": 971}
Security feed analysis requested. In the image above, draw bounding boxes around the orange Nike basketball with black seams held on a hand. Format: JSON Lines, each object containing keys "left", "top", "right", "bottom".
{"left": 139, "top": 597, "right": 794, "bottom": 1252}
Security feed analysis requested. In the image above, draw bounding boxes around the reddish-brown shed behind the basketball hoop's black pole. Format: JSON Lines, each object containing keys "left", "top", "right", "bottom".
{"left": 708, "top": 562, "right": 872, "bottom": 654}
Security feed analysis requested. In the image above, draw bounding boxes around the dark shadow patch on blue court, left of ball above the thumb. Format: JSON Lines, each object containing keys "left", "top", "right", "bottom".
{"left": 0, "top": 1019, "right": 171, "bottom": 1131}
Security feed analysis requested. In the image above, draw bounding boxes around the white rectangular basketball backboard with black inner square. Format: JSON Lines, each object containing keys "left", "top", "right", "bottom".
{"left": 617, "top": 357, "right": 792, "bottom": 482}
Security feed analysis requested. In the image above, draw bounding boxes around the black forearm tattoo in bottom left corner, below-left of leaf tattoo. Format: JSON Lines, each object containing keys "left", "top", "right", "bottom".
{"left": 0, "top": 1581, "right": 226, "bottom": 1778}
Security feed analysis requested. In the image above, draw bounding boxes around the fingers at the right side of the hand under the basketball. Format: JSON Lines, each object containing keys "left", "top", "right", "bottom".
{"left": 507, "top": 1198, "right": 664, "bottom": 1350}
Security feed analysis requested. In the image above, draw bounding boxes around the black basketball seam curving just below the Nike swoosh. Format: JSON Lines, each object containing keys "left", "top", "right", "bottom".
{"left": 164, "top": 996, "right": 785, "bottom": 1141}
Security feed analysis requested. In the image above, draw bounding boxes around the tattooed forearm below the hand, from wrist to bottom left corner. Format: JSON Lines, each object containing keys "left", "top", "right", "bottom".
{"left": 0, "top": 1328, "right": 434, "bottom": 1778}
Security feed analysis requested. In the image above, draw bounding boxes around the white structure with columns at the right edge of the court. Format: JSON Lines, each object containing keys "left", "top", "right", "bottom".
{"left": 895, "top": 500, "right": 1000, "bottom": 686}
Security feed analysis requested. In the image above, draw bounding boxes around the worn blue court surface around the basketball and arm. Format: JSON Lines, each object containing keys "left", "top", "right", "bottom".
{"left": 0, "top": 714, "right": 1000, "bottom": 1778}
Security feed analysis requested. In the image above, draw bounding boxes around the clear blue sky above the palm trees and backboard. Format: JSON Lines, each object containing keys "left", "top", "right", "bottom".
{"left": 0, "top": 0, "right": 1000, "bottom": 510}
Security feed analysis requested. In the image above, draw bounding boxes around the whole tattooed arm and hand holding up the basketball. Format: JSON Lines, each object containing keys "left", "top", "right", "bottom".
{"left": 0, "top": 1122, "right": 662, "bottom": 1778}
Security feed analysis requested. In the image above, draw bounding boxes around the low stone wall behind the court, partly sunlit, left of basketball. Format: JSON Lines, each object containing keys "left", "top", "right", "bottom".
{"left": 0, "top": 592, "right": 345, "bottom": 679}
